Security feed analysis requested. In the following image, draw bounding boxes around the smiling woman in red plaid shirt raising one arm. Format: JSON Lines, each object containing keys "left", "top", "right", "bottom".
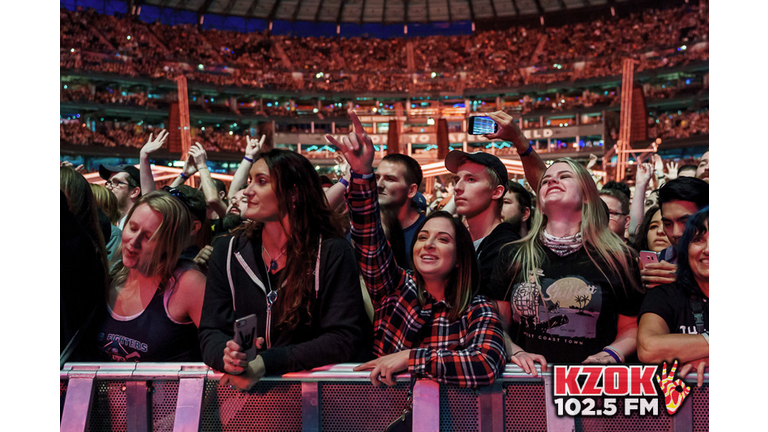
{"left": 326, "top": 111, "right": 505, "bottom": 387}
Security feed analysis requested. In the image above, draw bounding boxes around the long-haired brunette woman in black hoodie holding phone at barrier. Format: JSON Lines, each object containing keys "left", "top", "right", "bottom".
{"left": 200, "top": 149, "right": 371, "bottom": 390}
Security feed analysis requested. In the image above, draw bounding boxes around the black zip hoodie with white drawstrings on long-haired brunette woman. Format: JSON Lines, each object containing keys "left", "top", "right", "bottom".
{"left": 199, "top": 233, "right": 373, "bottom": 375}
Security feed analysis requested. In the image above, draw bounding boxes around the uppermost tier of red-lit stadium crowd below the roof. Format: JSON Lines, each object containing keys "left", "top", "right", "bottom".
{"left": 60, "top": 5, "right": 709, "bottom": 92}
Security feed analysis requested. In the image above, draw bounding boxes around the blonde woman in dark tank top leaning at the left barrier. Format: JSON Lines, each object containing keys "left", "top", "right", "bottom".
{"left": 96, "top": 191, "right": 205, "bottom": 362}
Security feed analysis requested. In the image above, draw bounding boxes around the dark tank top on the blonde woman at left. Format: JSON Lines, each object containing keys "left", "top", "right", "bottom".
{"left": 96, "top": 269, "right": 202, "bottom": 362}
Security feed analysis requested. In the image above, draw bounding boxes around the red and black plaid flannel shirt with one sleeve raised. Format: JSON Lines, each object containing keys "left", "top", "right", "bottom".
{"left": 347, "top": 176, "right": 506, "bottom": 387}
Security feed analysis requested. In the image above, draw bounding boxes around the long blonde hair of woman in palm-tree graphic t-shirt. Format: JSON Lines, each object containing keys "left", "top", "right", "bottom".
{"left": 505, "top": 158, "right": 642, "bottom": 295}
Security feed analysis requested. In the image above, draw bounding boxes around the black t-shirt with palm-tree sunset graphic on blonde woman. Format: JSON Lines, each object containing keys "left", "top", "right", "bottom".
{"left": 488, "top": 247, "right": 643, "bottom": 363}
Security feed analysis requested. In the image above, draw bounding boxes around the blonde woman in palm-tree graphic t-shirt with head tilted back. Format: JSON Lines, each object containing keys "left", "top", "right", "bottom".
{"left": 489, "top": 158, "right": 643, "bottom": 374}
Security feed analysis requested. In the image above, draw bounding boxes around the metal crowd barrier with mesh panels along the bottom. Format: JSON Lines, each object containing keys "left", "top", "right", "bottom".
{"left": 60, "top": 363, "right": 709, "bottom": 432}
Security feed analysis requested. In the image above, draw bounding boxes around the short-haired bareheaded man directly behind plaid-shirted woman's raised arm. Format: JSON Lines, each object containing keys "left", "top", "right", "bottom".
{"left": 376, "top": 154, "right": 426, "bottom": 268}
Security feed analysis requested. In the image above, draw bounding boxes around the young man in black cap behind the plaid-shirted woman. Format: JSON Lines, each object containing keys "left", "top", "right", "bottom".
{"left": 445, "top": 150, "right": 520, "bottom": 292}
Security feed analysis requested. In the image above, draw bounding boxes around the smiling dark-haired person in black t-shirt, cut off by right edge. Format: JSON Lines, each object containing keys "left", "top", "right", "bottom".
{"left": 637, "top": 207, "right": 709, "bottom": 387}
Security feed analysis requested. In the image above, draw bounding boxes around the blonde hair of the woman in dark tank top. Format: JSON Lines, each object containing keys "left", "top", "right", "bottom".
{"left": 110, "top": 191, "right": 192, "bottom": 286}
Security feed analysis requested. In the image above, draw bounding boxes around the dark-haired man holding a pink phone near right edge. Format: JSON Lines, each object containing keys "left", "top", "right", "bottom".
{"left": 640, "top": 177, "right": 709, "bottom": 288}
